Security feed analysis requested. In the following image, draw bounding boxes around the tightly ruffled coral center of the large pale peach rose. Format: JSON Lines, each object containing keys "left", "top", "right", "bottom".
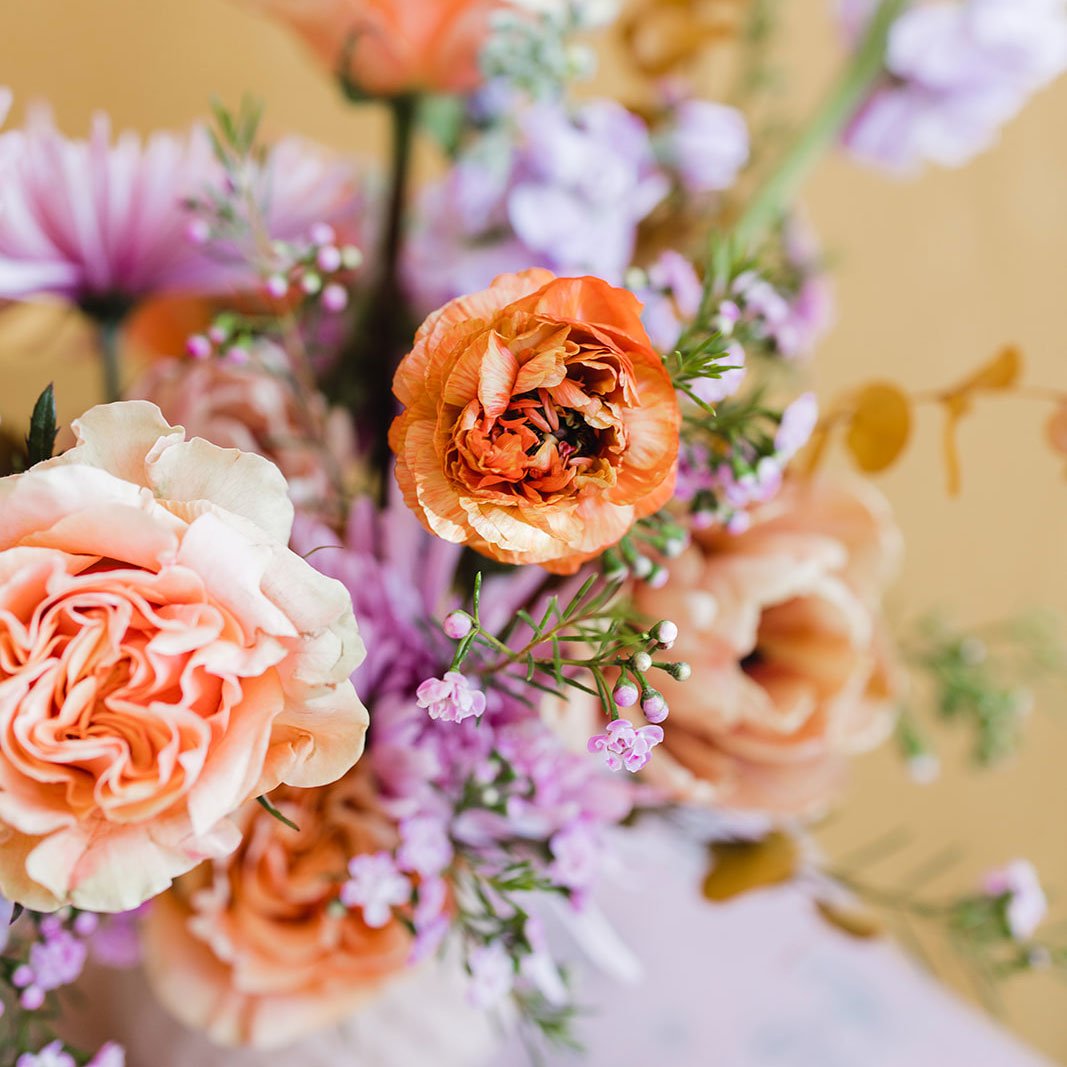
{"left": 0, "top": 557, "right": 269, "bottom": 823}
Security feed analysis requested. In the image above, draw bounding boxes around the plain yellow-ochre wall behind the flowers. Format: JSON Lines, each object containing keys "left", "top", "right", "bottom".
{"left": 0, "top": 0, "right": 1067, "bottom": 1067}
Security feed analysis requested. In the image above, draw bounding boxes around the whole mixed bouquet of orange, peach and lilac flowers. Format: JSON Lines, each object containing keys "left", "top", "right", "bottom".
{"left": 0, "top": 0, "right": 1067, "bottom": 1067}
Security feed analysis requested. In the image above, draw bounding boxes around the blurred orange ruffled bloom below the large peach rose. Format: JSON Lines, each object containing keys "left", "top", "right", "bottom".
{"left": 143, "top": 771, "right": 411, "bottom": 1048}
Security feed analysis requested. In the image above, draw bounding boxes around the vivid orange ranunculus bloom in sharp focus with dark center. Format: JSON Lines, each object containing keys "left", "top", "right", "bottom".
{"left": 389, "top": 270, "right": 680, "bottom": 574}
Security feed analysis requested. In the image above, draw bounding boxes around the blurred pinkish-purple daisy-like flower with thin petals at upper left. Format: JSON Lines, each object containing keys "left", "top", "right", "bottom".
{"left": 0, "top": 100, "right": 366, "bottom": 318}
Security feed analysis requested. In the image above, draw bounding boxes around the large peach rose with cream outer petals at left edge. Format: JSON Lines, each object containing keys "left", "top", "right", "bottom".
{"left": 0, "top": 401, "right": 367, "bottom": 911}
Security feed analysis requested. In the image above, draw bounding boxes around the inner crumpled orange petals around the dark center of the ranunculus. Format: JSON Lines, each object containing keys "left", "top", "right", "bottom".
{"left": 446, "top": 321, "right": 637, "bottom": 504}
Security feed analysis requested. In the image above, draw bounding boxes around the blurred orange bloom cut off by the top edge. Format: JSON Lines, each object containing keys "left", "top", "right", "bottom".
{"left": 244, "top": 0, "right": 504, "bottom": 96}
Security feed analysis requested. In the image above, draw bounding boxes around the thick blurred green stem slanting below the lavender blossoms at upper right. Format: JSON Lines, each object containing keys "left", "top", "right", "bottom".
{"left": 735, "top": 0, "right": 910, "bottom": 249}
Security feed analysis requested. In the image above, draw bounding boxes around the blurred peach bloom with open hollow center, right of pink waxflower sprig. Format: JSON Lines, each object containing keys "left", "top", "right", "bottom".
{"left": 636, "top": 481, "right": 901, "bottom": 816}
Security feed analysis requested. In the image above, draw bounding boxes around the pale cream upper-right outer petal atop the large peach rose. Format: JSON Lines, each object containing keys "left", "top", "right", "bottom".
{"left": 147, "top": 437, "right": 293, "bottom": 544}
